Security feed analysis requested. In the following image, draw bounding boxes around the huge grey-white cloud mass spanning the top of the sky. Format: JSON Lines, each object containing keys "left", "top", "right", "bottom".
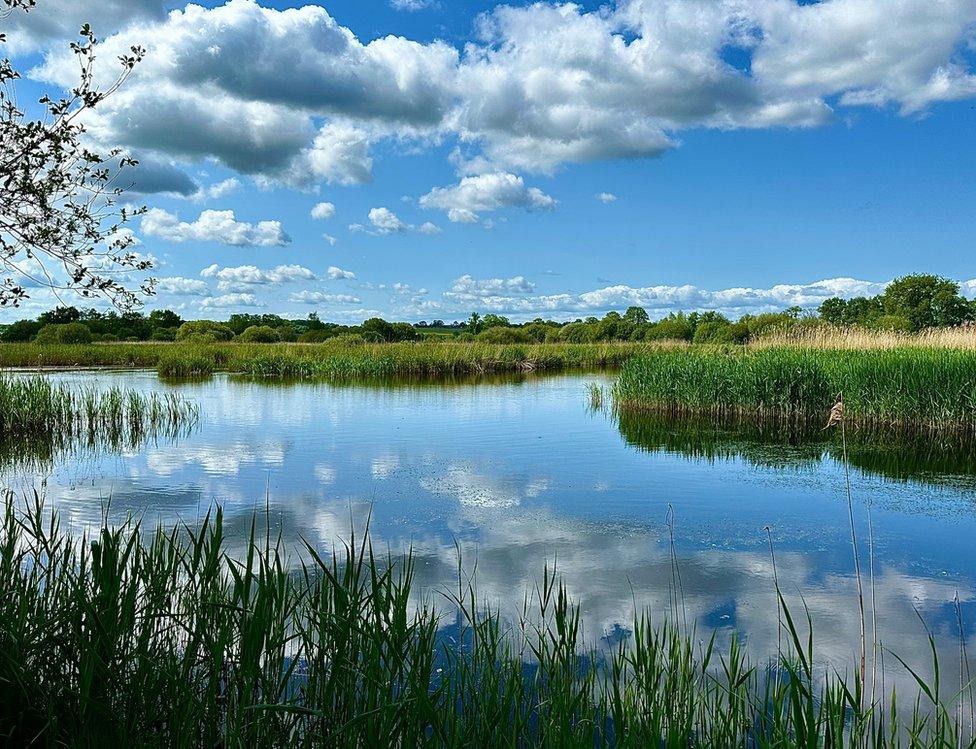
{"left": 19, "top": 0, "right": 976, "bottom": 190}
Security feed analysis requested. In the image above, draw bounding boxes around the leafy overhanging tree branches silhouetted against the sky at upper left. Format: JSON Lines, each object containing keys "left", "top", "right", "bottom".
{"left": 0, "top": 0, "right": 154, "bottom": 309}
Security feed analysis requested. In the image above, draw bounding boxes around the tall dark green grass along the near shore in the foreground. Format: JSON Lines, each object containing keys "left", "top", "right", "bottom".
{"left": 0, "top": 496, "right": 972, "bottom": 747}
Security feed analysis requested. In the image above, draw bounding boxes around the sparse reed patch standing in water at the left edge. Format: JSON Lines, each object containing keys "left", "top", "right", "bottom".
{"left": 0, "top": 376, "right": 198, "bottom": 442}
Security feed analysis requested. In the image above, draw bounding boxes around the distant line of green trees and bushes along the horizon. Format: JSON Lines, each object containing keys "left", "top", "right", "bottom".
{"left": 0, "top": 274, "right": 976, "bottom": 344}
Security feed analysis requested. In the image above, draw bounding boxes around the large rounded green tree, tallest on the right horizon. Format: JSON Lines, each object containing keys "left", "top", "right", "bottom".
{"left": 881, "top": 274, "right": 976, "bottom": 330}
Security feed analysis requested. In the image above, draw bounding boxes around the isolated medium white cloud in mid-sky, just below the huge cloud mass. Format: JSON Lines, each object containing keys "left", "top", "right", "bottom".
{"left": 420, "top": 172, "right": 556, "bottom": 223}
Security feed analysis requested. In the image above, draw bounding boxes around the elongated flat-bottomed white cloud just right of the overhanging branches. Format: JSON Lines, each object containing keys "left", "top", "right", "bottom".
{"left": 142, "top": 208, "right": 291, "bottom": 247}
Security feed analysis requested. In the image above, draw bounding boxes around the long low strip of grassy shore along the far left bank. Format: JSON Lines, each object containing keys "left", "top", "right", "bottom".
{"left": 0, "top": 342, "right": 656, "bottom": 379}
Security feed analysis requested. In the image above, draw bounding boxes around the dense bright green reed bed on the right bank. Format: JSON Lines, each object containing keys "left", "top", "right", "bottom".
{"left": 614, "top": 347, "right": 976, "bottom": 430}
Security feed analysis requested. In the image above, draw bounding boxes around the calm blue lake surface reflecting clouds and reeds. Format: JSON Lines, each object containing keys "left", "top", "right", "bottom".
{"left": 0, "top": 372, "right": 976, "bottom": 684}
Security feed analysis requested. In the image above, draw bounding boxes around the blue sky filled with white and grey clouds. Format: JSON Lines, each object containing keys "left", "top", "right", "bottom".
{"left": 0, "top": 0, "right": 976, "bottom": 323}
